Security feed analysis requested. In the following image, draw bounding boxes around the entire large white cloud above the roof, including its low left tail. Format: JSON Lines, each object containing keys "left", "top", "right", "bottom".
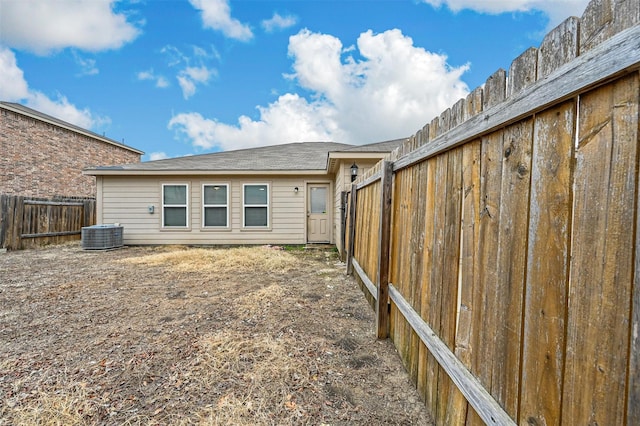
{"left": 169, "top": 30, "right": 468, "bottom": 150}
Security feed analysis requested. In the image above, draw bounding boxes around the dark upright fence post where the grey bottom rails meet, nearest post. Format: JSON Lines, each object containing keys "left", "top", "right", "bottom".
{"left": 376, "top": 160, "right": 393, "bottom": 339}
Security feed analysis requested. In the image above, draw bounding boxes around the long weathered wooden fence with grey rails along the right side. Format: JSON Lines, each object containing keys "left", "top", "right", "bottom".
{"left": 347, "top": 0, "right": 640, "bottom": 425}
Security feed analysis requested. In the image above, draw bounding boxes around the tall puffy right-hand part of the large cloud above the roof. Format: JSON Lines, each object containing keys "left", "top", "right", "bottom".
{"left": 289, "top": 29, "right": 468, "bottom": 143}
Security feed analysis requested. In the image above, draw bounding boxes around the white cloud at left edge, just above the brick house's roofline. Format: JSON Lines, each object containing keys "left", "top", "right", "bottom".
{"left": 0, "top": 47, "right": 110, "bottom": 129}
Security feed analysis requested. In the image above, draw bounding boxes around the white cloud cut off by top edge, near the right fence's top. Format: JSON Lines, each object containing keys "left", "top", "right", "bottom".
{"left": 422, "top": 0, "right": 589, "bottom": 28}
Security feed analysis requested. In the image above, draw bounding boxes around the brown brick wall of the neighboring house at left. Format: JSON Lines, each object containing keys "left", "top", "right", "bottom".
{"left": 0, "top": 108, "right": 140, "bottom": 198}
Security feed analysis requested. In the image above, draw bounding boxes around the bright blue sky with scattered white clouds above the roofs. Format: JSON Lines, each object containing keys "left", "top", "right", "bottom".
{"left": 0, "top": 0, "right": 588, "bottom": 160}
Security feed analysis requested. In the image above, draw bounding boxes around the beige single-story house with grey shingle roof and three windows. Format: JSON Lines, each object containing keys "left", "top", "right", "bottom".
{"left": 84, "top": 139, "right": 404, "bottom": 255}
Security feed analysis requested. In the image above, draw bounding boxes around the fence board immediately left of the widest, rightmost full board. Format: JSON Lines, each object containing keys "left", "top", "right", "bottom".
{"left": 520, "top": 101, "right": 576, "bottom": 426}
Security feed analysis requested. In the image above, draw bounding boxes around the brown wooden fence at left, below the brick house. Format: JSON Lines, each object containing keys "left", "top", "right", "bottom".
{"left": 0, "top": 195, "right": 96, "bottom": 250}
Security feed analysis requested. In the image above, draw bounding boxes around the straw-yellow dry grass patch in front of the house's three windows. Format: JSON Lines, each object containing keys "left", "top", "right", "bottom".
{"left": 122, "top": 247, "right": 298, "bottom": 273}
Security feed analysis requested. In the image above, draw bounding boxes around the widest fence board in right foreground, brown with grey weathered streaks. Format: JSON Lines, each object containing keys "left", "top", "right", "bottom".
{"left": 562, "top": 70, "right": 640, "bottom": 424}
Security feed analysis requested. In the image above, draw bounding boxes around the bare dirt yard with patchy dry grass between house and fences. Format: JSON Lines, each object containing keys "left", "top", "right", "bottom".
{"left": 0, "top": 243, "right": 431, "bottom": 425}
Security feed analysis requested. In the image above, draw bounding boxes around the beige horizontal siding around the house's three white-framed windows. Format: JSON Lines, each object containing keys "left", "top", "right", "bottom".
{"left": 98, "top": 176, "right": 311, "bottom": 245}
